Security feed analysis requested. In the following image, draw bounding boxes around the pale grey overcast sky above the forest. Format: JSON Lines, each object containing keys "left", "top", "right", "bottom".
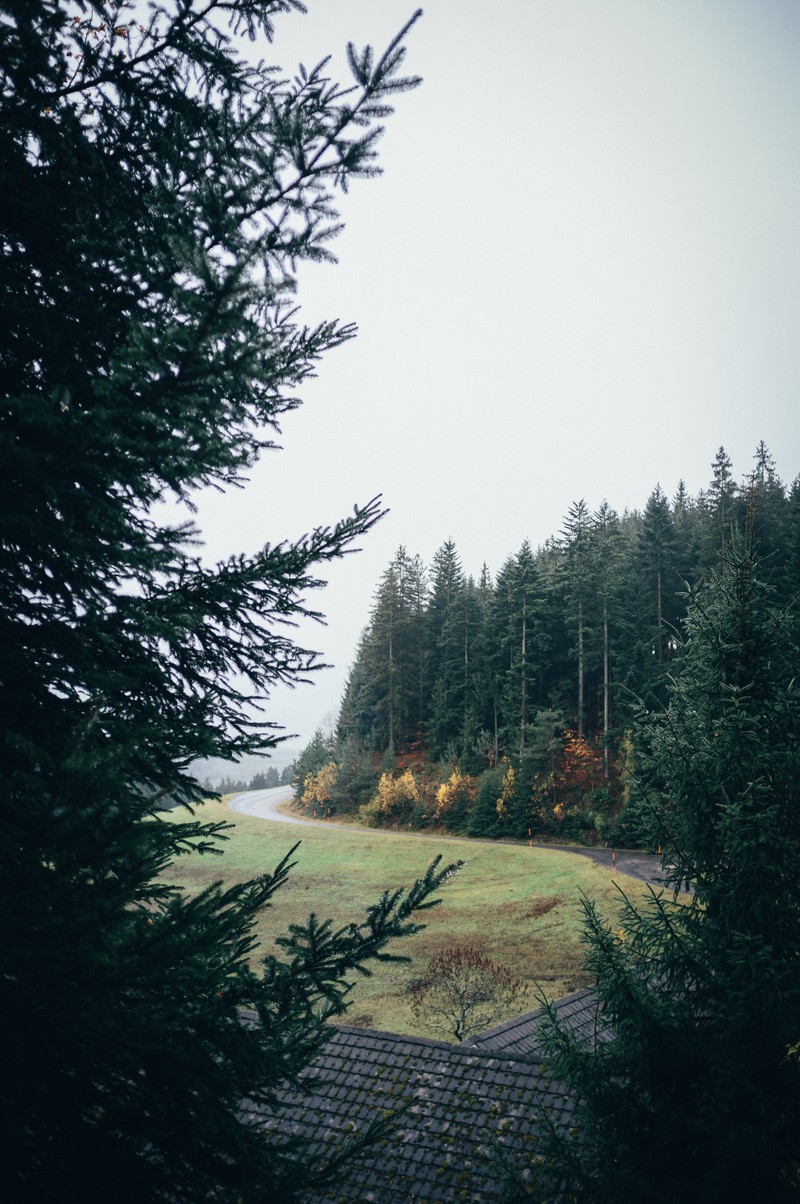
{"left": 189, "top": 0, "right": 800, "bottom": 769}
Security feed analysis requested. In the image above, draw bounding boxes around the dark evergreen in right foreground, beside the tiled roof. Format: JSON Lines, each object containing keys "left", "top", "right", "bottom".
{"left": 537, "top": 541, "right": 800, "bottom": 1204}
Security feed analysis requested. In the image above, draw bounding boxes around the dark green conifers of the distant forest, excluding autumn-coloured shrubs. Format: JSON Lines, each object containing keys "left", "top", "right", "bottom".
{"left": 322, "top": 443, "right": 800, "bottom": 846}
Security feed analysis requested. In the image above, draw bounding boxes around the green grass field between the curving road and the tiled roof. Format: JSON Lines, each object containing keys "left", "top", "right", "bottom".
{"left": 161, "top": 802, "right": 646, "bottom": 1037}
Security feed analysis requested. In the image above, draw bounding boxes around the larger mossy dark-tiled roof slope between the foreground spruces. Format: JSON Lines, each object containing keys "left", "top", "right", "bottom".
{"left": 253, "top": 1017, "right": 571, "bottom": 1204}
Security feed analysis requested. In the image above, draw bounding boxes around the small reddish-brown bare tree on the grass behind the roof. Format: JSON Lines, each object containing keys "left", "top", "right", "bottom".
{"left": 411, "top": 945, "right": 530, "bottom": 1041}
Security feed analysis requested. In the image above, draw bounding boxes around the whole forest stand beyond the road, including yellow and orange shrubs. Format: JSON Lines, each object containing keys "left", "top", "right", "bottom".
{"left": 294, "top": 443, "right": 800, "bottom": 844}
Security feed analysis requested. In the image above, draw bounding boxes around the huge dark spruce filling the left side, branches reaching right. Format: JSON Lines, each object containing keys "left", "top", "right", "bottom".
{"left": 0, "top": 0, "right": 462, "bottom": 1204}
